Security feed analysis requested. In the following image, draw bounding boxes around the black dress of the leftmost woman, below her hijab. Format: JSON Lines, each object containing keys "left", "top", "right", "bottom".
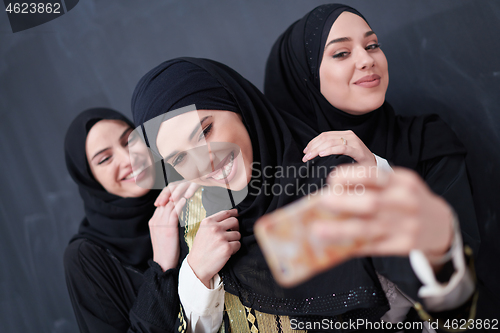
{"left": 64, "top": 239, "right": 183, "bottom": 333}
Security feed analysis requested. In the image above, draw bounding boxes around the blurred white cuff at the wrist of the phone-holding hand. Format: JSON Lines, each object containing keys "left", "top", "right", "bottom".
{"left": 410, "top": 215, "right": 475, "bottom": 312}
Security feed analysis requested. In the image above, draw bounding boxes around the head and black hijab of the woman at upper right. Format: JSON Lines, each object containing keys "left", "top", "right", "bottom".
{"left": 264, "top": 4, "right": 465, "bottom": 171}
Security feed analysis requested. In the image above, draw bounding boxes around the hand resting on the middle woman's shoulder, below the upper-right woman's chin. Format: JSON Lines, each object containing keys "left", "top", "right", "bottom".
{"left": 302, "top": 130, "right": 377, "bottom": 166}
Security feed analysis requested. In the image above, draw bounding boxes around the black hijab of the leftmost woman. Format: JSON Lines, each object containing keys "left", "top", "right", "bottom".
{"left": 64, "top": 108, "right": 159, "bottom": 269}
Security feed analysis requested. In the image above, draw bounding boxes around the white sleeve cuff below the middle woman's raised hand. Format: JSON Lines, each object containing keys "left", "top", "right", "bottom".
{"left": 179, "top": 257, "right": 224, "bottom": 316}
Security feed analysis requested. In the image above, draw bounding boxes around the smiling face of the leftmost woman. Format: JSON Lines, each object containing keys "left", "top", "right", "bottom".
{"left": 85, "top": 119, "right": 153, "bottom": 198}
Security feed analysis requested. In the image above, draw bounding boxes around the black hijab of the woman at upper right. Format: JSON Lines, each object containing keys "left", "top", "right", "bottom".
{"left": 264, "top": 4, "right": 465, "bottom": 171}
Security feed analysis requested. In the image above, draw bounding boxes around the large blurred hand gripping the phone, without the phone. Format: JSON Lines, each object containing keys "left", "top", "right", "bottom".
{"left": 313, "top": 164, "right": 453, "bottom": 268}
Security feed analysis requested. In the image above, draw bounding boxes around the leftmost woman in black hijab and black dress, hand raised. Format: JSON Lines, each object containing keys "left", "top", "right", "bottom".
{"left": 64, "top": 108, "right": 185, "bottom": 333}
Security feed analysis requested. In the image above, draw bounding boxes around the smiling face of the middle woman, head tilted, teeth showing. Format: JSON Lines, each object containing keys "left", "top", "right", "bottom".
{"left": 156, "top": 110, "right": 253, "bottom": 191}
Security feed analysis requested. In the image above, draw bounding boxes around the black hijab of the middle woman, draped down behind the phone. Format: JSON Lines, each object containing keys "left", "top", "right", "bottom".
{"left": 132, "top": 58, "right": 388, "bottom": 320}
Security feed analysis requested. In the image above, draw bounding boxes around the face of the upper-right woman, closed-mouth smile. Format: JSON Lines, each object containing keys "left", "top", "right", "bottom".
{"left": 319, "top": 12, "right": 389, "bottom": 115}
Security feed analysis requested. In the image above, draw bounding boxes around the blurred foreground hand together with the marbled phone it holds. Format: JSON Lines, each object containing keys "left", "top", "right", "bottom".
{"left": 255, "top": 164, "right": 453, "bottom": 287}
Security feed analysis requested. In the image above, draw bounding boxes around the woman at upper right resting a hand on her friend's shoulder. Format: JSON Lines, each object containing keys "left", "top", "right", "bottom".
{"left": 264, "top": 0, "right": 480, "bottom": 314}
